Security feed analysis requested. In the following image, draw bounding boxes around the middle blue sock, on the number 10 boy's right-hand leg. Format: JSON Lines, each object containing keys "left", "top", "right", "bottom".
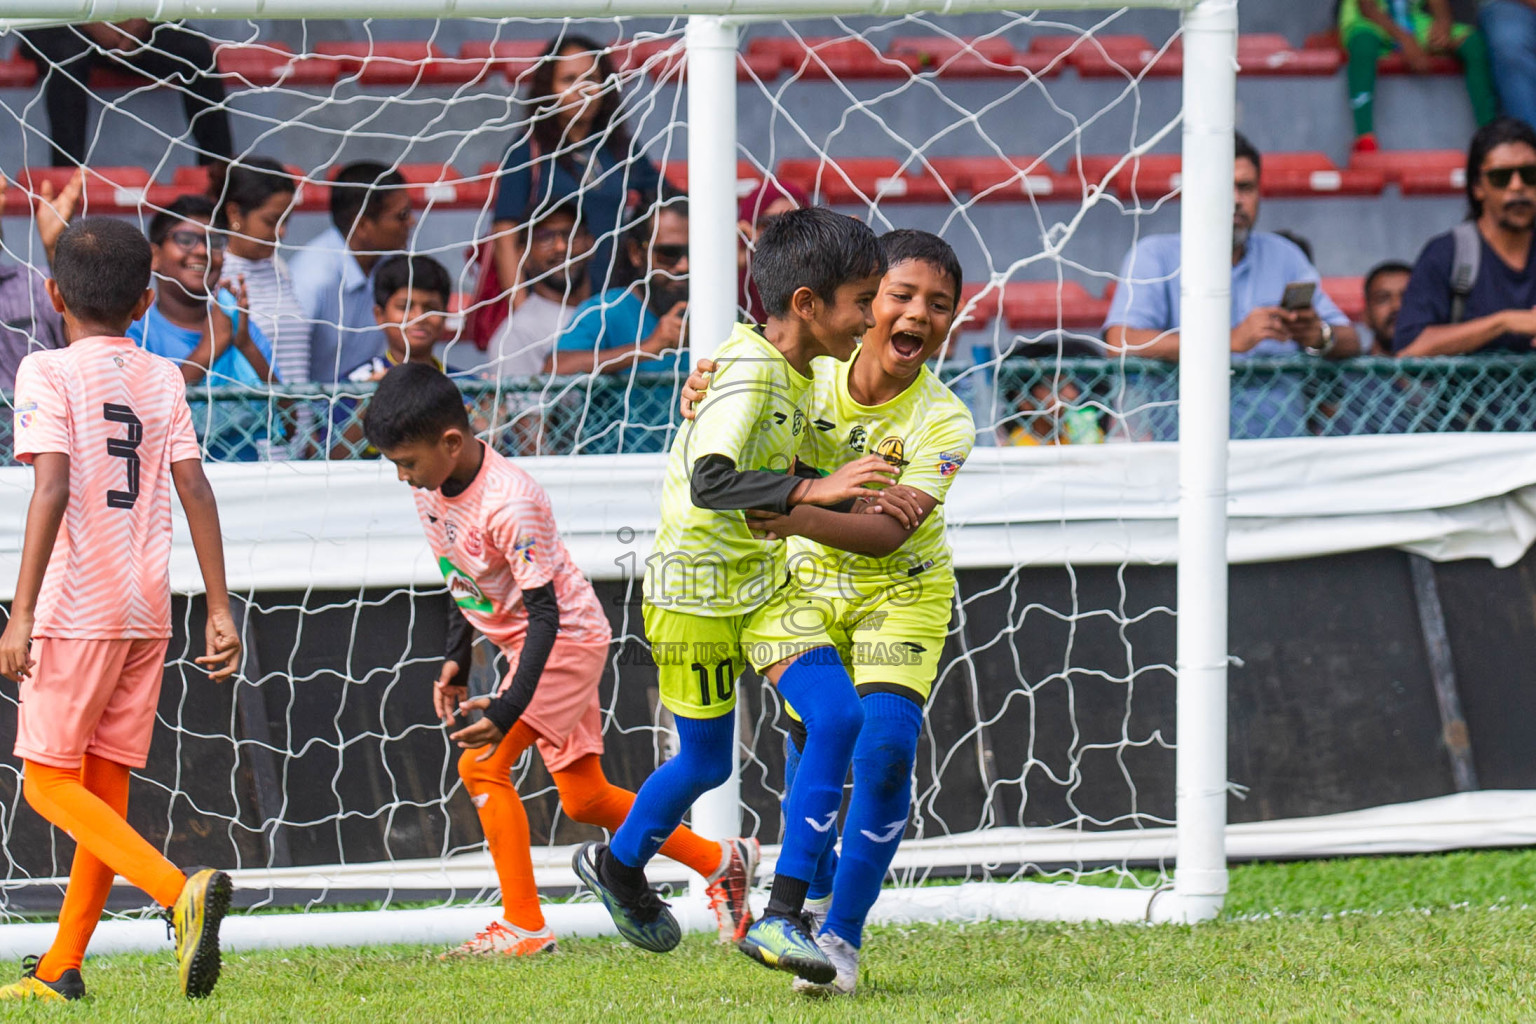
{"left": 774, "top": 646, "right": 863, "bottom": 890}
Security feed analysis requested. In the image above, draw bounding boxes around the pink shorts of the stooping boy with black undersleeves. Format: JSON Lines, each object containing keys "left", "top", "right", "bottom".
{"left": 501, "top": 639, "right": 608, "bottom": 772}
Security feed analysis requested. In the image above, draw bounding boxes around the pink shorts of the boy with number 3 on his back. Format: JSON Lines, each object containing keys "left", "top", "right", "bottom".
{"left": 15, "top": 637, "right": 170, "bottom": 768}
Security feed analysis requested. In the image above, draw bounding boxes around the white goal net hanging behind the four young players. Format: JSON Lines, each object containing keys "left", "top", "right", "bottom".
{"left": 0, "top": 3, "right": 1232, "bottom": 941}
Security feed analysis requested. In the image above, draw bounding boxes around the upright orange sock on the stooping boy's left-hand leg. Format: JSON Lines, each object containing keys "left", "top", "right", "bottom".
{"left": 459, "top": 722, "right": 544, "bottom": 932}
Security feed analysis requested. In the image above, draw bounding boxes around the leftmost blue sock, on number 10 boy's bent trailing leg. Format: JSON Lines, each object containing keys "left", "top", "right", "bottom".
{"left": 608, "top": 711, "right": 736, "bottom": 867}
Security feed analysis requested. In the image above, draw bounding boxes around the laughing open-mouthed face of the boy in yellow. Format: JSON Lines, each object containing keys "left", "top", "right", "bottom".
{"left": 865, "top": 259, "right": 960, "bottom": 381}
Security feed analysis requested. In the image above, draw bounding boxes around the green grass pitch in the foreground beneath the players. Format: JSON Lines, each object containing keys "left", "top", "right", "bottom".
{"left": 0, "top": 851, "right": 1536, "bottom": 1024}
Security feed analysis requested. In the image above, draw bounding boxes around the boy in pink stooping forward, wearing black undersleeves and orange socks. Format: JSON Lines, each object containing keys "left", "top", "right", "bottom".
{"left": 364, "top": 362, "right": 757, "bottom": 956}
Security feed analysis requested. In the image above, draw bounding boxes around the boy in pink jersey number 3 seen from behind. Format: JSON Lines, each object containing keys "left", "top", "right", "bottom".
{"left": 0, "top": 218, "right": 240, "bottom": 1001}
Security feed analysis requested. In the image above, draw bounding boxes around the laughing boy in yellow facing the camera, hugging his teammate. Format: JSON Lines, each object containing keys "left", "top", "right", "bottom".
{"left": 684, "top": 230, "right": 975, "bottom": 993}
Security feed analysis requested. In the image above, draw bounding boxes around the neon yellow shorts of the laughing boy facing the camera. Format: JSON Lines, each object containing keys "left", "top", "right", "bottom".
{"left": 740, "top": 573, "right": 954, "bottom": 705}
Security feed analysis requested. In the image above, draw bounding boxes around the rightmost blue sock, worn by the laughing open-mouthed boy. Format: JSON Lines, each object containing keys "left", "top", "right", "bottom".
{"left": 823, "top": 694, "right": 923, "bottom": 947}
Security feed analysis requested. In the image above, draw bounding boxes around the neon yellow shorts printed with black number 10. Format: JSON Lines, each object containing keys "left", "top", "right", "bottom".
{"left": 641, "top": 605, "right": 746, "bottom": 718}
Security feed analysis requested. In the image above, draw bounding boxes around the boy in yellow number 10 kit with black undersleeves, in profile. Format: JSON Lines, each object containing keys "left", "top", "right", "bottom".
{"left": 574, "top": 209, "right": 894, "bottom": 981}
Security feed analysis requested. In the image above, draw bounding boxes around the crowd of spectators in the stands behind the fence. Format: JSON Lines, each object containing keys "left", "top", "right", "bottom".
{"left": 0, "top": 22, "right": 1536, "bottom": 457}
